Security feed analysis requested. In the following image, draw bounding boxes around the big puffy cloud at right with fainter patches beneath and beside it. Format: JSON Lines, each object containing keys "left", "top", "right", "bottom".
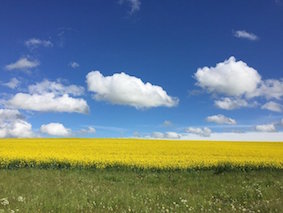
{"left": 194, "top": 56, "right": 283, "bottom": 111}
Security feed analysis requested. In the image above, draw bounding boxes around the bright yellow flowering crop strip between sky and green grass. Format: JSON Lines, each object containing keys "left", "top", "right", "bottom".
{"left": 0, "top": 138, "right": 283, "bottom": 168}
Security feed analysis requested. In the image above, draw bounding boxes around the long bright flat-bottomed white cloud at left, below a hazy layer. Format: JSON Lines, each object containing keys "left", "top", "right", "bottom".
{"left": 6, "top": 93, "right": 89, "bottom": 113}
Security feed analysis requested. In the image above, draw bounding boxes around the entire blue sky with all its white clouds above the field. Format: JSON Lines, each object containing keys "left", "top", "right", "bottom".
{"left": 0, "top": 0, "right": 283, "bottom": 141}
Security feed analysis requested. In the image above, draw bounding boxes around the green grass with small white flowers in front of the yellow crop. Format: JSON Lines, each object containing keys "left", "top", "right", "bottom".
{"left": 0, "top": 168, "right": 283, "bottom": 213}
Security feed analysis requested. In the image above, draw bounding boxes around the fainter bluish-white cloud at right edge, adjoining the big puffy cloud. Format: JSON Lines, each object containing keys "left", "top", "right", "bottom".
{"left": 248, "top": 79, "right": 283, "bottom": 100}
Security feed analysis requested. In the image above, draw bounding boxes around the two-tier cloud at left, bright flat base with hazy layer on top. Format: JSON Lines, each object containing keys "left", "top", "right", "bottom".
{"left": 5, "top": 80, "right": 89, "bottom": 113}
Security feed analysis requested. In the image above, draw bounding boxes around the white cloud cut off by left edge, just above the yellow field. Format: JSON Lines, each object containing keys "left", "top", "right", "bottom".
{"left": 0, "top": 109, "right": 34, "bottom": 138}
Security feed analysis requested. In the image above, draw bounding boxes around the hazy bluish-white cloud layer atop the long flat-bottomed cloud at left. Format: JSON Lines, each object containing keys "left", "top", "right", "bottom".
{"left": 28, "top": 80, "right": 84, "bottom": 96}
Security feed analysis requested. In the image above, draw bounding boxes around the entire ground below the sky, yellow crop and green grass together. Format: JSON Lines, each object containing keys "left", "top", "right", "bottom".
{"left": 0, "top": 138, "right": 283, "bottom": 212}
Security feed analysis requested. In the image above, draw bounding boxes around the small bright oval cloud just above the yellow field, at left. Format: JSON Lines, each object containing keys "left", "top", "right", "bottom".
{"left": 40, "top": 123, "right": 71, "bottom": 137}
